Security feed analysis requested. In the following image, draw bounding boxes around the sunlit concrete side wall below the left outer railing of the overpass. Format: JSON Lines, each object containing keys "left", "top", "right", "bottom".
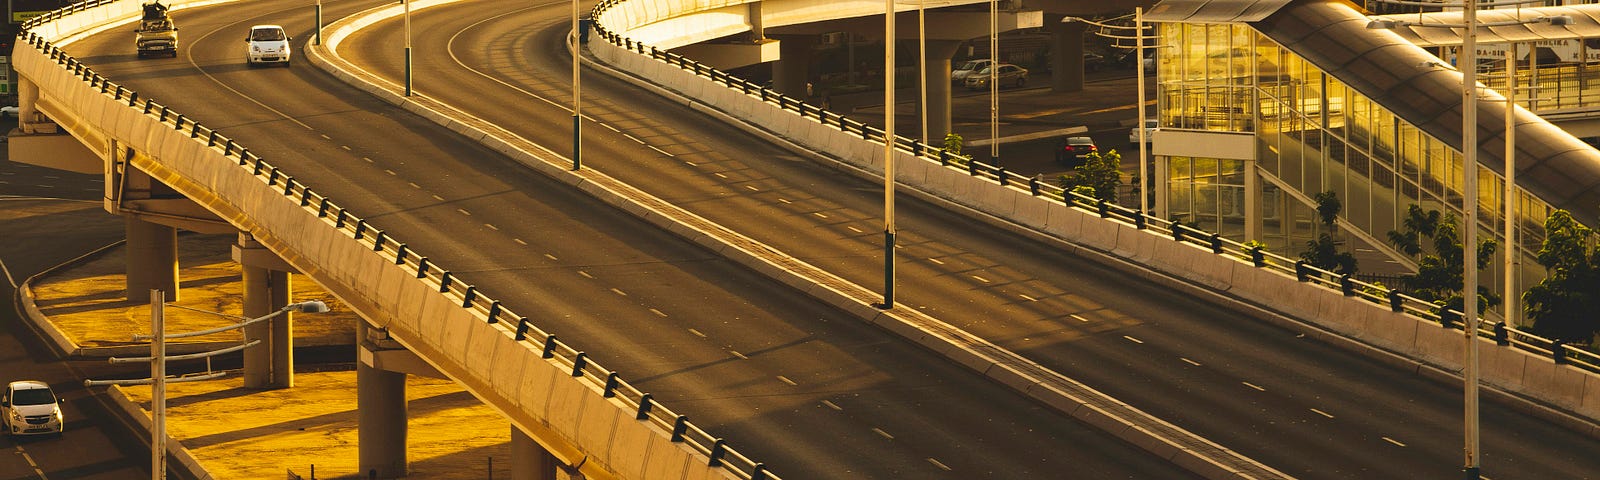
{"left": 13, "top": 2, "right": 736, "bottom": 480}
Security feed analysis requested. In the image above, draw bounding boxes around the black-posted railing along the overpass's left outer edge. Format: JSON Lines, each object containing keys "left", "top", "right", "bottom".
{"left": 18, "top": 0, "right": 779, "bottom": 480}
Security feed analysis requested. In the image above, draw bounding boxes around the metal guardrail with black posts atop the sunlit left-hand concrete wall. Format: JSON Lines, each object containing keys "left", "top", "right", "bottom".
{"left": 18, "top": 0, "right": 779, "bottom": 480}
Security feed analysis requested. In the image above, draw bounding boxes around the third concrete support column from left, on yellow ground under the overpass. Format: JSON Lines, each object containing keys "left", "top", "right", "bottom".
{"left": 355, "top": 322, "right": 408, "bottom": 478}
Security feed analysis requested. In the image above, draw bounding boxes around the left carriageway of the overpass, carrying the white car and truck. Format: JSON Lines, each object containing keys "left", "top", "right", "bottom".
{"left": 67, "top": 0, "right": 1190, "bottom": 478}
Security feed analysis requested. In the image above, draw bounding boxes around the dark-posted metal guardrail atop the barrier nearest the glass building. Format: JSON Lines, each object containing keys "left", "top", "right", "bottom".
{"left": 590, "top": 0, "right": 1600, "bottom": 373}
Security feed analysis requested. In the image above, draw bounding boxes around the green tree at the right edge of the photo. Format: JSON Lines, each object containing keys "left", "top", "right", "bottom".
{"left": 1522, "top": 210, "right": 1600, "bottom": 344}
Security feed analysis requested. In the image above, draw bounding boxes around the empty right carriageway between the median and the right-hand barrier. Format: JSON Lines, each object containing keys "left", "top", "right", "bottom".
{"left": 331, "top": 0, "right": 1600, "bottom": 478}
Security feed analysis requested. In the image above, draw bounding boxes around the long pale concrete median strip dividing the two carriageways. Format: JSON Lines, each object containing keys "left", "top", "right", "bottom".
{"left": 307, "top": 0, "right": 1290, "bottom": 478}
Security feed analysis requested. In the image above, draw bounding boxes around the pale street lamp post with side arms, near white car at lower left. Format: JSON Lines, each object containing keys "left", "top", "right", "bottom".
{"left": 83, "top": 290, "right": 328, "bottom": 480}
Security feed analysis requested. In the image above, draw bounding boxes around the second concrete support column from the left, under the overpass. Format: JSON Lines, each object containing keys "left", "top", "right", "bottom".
{"left": 234, "top": 234, "right": 294, "bottom": 389}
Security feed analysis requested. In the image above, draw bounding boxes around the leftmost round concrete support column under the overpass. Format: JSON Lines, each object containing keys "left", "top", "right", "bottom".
{"left": 125, "top": 216, "right": 178, "bottom": 304}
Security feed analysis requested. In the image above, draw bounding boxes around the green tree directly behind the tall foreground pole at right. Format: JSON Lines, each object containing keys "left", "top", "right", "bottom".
{"left": 1389, "top": 205, "right": 1501, "bottom": 309}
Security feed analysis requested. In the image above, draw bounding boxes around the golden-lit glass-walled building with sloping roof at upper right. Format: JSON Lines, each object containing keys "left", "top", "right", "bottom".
{"left": 1152, "top": 22, "right": 1554, "bottom": 318}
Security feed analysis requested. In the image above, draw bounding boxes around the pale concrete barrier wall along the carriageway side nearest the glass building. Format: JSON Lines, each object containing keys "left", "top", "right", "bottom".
{"left": 587, "top": 13, "right": 1600, "bottom": 421}
